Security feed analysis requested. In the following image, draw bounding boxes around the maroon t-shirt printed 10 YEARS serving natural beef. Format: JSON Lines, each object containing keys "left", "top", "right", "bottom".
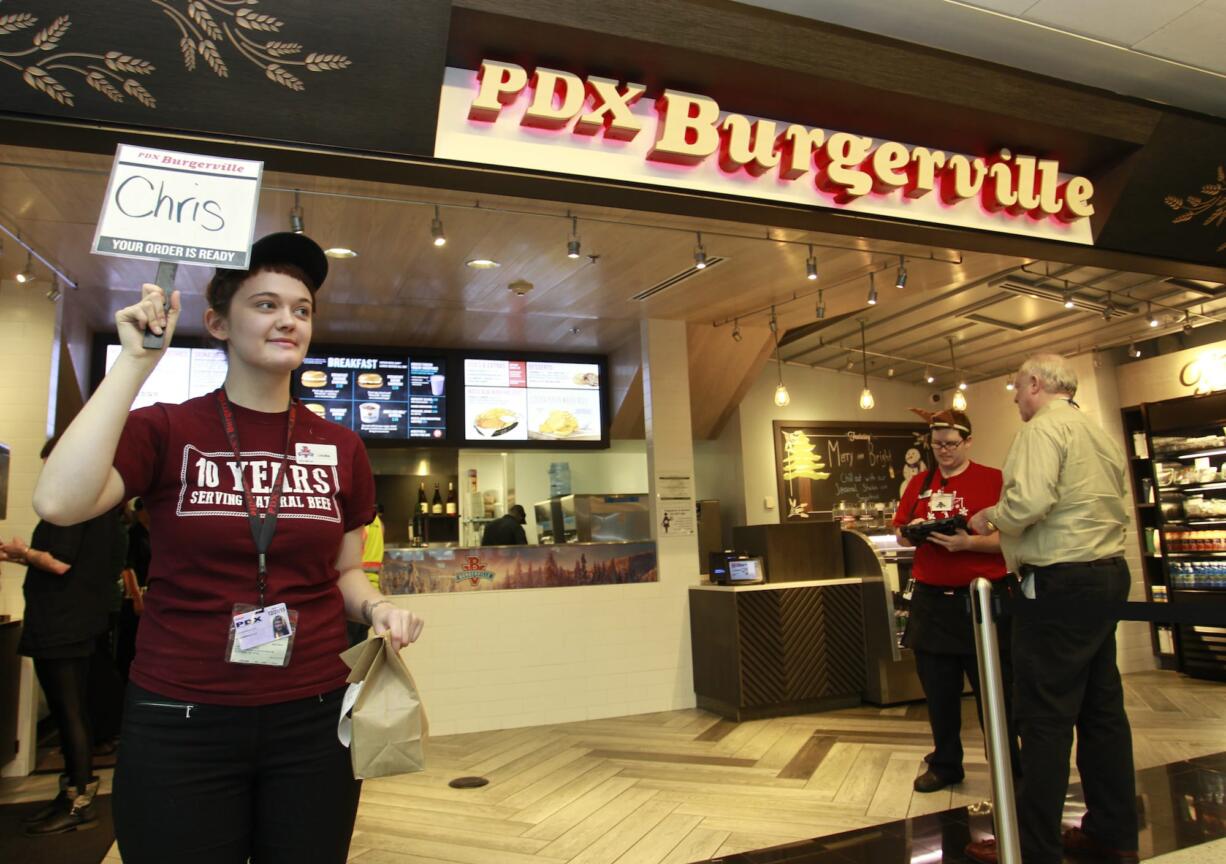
{"left": 115, "top": 392, "right": 374, "bottom": 705}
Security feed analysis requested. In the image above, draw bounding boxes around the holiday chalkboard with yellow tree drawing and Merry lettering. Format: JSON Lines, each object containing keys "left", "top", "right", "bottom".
{"left": 774, "top": 420, "right": 933, "bottom": 522}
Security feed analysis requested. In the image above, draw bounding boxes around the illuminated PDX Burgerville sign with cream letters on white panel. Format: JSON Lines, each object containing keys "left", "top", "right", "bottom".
{"left": 434, "top": 59, "right": 1094, "bottom": 245}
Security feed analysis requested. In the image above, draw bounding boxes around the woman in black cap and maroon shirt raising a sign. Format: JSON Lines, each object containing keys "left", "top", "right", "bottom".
{"left": 34, "top": 233, "right": 422, "bottom": 864}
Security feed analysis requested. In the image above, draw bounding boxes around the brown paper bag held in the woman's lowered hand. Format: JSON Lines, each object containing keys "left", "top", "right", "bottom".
{"left": 337, "top": 636, "right": 429, "bottom": 779}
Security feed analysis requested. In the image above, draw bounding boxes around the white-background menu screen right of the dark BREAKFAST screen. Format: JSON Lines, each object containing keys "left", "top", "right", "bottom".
{"left": 463, "top": 358, "right": 604, "bottom": 442}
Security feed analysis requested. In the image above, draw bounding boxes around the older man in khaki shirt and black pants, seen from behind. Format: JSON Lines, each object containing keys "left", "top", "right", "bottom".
{"left": 966, "top": 354, "right": 1138, "bottom": 864}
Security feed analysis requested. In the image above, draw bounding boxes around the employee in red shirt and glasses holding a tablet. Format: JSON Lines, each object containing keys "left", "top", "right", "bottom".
{"left": 894, "top": 408, "right": 1018, "bottom": 792}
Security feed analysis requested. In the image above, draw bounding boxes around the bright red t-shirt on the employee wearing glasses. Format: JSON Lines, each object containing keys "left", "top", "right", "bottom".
{"left": 894, "top": 462, "right": 1005, "bottom": 588}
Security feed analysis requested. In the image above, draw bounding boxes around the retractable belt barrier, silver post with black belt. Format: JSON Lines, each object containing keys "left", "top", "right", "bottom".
{"left": 967, "top": 578, "right": 1226, "bottom": 864}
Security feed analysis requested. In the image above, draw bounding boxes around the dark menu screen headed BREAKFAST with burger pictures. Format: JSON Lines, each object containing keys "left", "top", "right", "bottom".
{"left": 293, "top": 354, "right": 446, "bottom": 441}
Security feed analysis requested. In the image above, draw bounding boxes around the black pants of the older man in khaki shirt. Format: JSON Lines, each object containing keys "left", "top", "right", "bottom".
{"left": 1013, "top": 559, "right": 1137, "bottom": 864}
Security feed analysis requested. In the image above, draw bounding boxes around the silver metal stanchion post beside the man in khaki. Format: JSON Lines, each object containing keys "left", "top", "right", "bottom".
{"left": 971, "top": 577, "right": 1021, "bottom": 864}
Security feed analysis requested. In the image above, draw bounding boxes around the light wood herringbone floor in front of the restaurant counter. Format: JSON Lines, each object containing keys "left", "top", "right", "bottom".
{"left": 0, "top": 673, "right": 1226, "bottom": 864}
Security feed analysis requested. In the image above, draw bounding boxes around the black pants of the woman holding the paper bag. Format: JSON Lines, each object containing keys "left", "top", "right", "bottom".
{"left": 114, "top": 684, "right": 362, "bottom": 864}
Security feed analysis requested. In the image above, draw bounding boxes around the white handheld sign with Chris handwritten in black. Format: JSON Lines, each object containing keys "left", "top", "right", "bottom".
{"left": 93, "top": 145, "right": 264, "bottom": 270}
